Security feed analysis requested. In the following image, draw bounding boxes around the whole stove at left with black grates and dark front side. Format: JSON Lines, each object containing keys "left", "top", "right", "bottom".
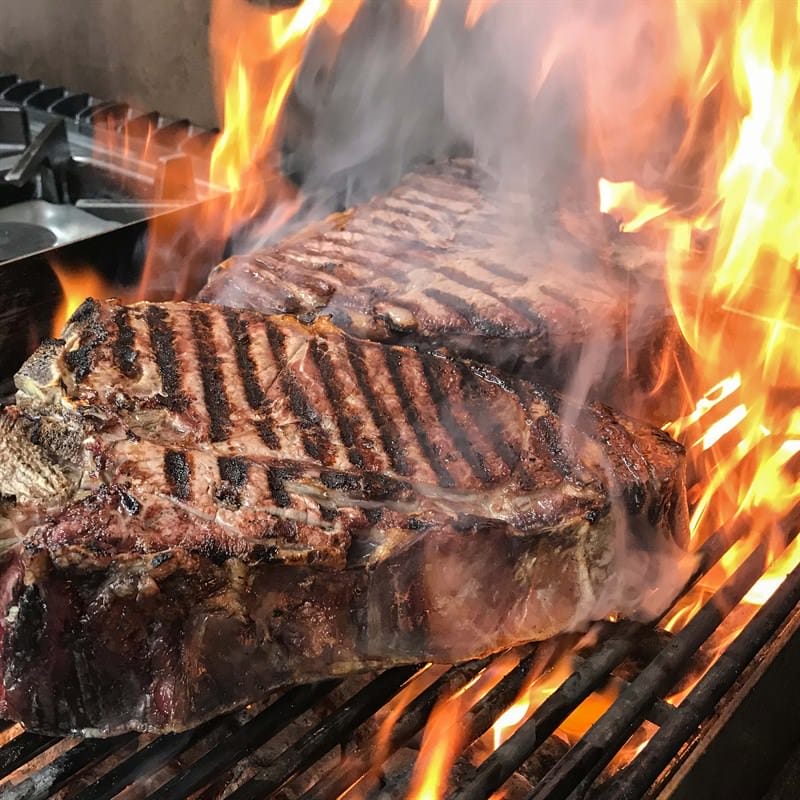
{"left": 0, "top": 75, "right": 239, "bottom": 398}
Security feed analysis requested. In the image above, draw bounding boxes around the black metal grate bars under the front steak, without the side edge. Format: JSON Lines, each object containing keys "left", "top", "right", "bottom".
{"left": 0, "top": 514, "right": 800, "bottom": 800}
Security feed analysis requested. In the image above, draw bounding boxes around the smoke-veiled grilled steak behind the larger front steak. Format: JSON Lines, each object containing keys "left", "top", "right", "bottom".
{"left": 200, "top": 160, "right": 669, "bottom": 385}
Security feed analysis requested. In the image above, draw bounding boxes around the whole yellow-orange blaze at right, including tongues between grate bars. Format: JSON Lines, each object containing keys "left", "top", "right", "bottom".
{"left": 599, "top": 0, "right": 800, "bottom": 720}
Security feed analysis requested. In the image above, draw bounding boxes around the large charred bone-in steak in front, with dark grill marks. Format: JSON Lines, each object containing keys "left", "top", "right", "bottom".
{"left": 0, "top": 300, "right": 686, "bottom": 734}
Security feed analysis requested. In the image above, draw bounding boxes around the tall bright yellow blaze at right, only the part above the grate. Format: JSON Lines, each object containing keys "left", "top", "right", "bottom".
{"left": 648, "top": 0, "right": 800, "bottom": 568}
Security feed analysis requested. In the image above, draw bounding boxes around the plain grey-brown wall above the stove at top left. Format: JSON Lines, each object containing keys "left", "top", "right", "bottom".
{"left": 0, "top": 0, "right": 216, "bottom": 127}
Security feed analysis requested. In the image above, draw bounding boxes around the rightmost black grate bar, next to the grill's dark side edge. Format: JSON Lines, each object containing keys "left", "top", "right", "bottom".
{"left": 600, "top": 566, "right": 800, "bottom": 800}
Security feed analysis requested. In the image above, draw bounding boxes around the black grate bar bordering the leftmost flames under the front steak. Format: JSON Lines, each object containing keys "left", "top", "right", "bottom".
{"left": 229, "top": 665, "right": 420, "bottom": 800}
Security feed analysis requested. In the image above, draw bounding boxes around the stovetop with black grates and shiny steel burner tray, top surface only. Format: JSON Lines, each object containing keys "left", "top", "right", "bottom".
{"left": 0, "top": 75, "right": 219, "bottom": 264}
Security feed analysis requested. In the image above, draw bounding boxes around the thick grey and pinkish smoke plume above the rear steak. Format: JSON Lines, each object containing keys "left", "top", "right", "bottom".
{"left": 262, "top": 0, "right": 681, "bottom": 212}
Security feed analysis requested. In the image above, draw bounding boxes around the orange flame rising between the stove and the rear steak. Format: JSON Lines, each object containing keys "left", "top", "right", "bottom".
{"left": 81, "top": 0, "right": 362, "bottom": 306}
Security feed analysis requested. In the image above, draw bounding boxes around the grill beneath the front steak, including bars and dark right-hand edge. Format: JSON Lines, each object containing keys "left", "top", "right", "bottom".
{"left": 0, "top": 509, "right": 800, "bottom": 800}
